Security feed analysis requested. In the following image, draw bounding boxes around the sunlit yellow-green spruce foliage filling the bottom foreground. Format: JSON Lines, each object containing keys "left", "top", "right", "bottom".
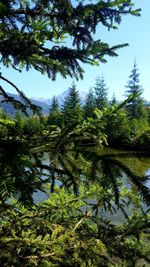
{"left": 0, "top": 185, "right": 150, "bottom": 267}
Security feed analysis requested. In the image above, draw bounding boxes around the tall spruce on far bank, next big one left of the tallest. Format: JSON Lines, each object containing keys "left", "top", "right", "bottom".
{"left": 94, "top": 76, "right": 108, "bottom": 110}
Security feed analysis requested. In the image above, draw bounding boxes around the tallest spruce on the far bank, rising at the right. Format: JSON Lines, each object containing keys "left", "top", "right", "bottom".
{"left": 126, "top": 61, "right": 146, "bottom": 119}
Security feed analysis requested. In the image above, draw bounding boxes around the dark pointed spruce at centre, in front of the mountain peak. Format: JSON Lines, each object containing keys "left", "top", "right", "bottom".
{"left": 62, "top": 83, "right": 82, "bottom": 125}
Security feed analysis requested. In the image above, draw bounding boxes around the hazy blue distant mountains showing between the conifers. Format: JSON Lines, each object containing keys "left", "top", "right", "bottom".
{"left": 0, "top": 89, "right": 87, "bottom": 116}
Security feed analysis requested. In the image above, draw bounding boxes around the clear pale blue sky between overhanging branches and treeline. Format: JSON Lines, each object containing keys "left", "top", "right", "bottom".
{"left": 0, "top": 0, "right": 150, "bottom": 101}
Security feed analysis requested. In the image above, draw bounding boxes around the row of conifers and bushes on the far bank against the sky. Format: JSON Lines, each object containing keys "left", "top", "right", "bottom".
{"left": 46, "top": 63, "right": 150, "bottom": 149}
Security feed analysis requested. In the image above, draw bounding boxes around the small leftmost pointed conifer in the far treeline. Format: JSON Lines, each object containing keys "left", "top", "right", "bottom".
{"left": 47, "top": 96, "right": 62, "bottom": 127}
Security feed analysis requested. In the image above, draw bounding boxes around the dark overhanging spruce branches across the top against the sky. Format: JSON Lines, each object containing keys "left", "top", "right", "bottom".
{"left": 0, "top": 0, "right": 140, "bottom": 79}
